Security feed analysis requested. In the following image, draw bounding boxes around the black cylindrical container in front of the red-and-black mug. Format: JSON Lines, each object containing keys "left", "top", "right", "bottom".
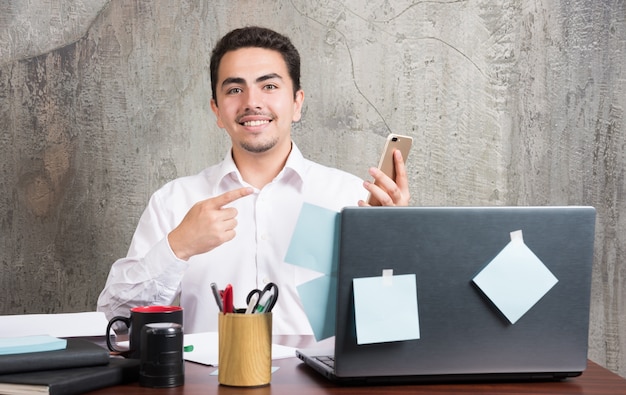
{"left": 139, "top": 322, "right": 185, "bottom": 388}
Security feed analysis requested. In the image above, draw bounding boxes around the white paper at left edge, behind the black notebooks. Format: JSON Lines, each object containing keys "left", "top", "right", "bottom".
{"left": 0, "top": 311, "right": 109, "bottom": 337}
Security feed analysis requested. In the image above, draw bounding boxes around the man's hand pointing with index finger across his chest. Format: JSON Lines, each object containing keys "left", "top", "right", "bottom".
{"left": 167, "top": 188, "right": 253, "bottom": 261}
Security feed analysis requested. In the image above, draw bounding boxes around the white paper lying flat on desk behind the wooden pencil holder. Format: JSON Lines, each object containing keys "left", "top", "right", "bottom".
{"left": 183, "top": 332, "right": 296, "bottom": 366}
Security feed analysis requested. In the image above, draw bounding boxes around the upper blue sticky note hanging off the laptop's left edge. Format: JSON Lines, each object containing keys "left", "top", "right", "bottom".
{"left": 285, "top": 203, "right": 339, "bottom": 275}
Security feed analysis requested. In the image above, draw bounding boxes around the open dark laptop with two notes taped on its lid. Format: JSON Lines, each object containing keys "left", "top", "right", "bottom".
{"left": 296, "top": 206, "right": 595, "bottom": 385}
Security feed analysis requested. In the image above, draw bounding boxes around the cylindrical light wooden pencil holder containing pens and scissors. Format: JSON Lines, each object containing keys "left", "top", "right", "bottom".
{"left": 217, "top": 313, "right": 272, "bottom": 387}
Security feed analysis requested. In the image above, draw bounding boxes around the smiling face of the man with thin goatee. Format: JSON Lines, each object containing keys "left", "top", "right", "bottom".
{"left": 211, "top": 48, "right": 304, "bottom": 154}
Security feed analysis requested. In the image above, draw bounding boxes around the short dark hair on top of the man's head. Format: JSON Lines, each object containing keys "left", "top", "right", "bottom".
{"left": 210, "top": 26, "right": 300, "bottom": 103}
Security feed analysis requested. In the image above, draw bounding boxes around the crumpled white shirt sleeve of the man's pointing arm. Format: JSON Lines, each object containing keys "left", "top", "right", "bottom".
{"left": 97, "top": 190, "right": 188, "bottom": 319}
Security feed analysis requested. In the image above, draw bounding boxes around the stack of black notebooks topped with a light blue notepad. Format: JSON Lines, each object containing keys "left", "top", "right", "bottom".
{"left": 0, "top": 336, "right": 139, "bottom": 395}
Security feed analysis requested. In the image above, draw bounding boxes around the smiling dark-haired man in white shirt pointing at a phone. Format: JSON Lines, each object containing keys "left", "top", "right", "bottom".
{"left": 98, "top": 27, "right": 409, "bottom": 334}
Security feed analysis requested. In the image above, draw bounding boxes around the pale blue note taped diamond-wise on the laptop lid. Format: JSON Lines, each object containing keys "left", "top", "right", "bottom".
{"left": 473, "top": 230, "right": 558, "bottom": 324}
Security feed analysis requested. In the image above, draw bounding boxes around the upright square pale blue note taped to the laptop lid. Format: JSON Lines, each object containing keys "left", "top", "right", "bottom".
{"left": 352, "top": 274, "right": 420, "bottom": 344}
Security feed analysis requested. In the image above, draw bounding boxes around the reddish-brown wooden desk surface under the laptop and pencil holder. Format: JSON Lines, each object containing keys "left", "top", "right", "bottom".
{"left": 90, "top": 357, "right": 626, "bottom": 395}
